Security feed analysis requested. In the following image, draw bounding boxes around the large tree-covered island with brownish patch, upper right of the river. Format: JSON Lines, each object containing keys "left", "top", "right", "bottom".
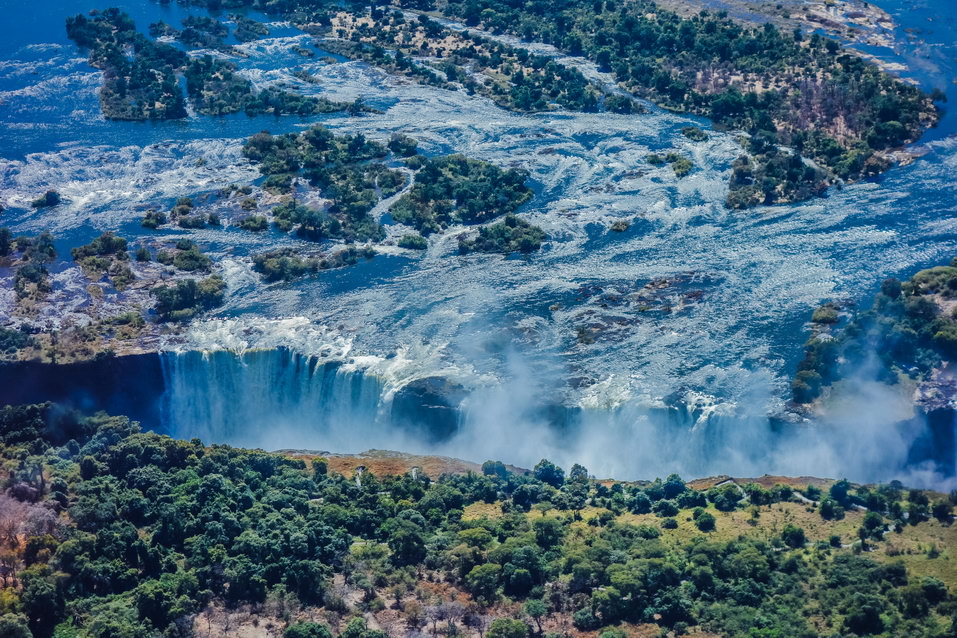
{"left": 443, "top": 0, "right": 938, "bottom": 207}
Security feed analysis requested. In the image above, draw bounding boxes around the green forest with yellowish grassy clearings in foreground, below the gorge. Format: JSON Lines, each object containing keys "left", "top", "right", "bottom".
{"left": 0, "top": 404, "right": 957, "bottom": 638}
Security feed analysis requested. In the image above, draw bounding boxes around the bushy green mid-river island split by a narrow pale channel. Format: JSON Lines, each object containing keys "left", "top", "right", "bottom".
{"left": 243, "top": 125, "right": 545, "bottom": 281}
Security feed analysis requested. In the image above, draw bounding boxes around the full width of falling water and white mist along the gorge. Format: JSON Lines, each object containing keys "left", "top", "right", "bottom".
{"left": 162, "top": 348, "right": 954, "bottom": 487}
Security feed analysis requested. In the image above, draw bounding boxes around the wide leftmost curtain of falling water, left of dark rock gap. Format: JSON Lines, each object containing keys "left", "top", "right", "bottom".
{"left": 160, "top": 348, "right": 452, "bottom": 452}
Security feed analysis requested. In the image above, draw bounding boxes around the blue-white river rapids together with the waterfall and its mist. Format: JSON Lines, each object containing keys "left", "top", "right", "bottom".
{"left": 0, "top": 0, "right": 957, "bottom": 479}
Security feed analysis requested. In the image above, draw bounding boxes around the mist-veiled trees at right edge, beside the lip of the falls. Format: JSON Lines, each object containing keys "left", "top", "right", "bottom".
{"left": 792, "top": 259, "right": 957, "bottom": 403}
